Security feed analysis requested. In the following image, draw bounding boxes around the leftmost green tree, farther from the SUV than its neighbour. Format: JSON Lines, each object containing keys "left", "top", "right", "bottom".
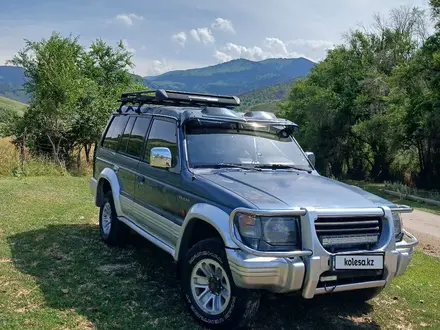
{"left": 12, "top": 33, "right": 83, "bottom": 164}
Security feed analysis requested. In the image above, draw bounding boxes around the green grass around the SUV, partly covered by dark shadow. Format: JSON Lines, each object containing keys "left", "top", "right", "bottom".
{"left": 0, "top": 176, "right": 440, "bottom": 330}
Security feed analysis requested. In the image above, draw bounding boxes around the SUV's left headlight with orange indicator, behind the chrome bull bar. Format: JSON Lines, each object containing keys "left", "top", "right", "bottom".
{"left": 234, "top": 213, "right": 299, "bottom": 251}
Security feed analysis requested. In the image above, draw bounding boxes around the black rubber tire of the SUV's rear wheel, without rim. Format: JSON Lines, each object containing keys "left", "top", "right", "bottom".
{"left": 99, "top": 191, "right": 128, "bottom": 246}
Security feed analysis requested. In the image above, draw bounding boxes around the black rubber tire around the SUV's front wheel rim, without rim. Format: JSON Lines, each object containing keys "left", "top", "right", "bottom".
{"left": 181, "top": 238, "right": 260, "bottom": 330}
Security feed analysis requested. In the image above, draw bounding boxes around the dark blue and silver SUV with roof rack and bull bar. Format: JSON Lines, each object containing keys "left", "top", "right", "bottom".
{"left": 90, "top": 90, "right": 418, "bottom": 328}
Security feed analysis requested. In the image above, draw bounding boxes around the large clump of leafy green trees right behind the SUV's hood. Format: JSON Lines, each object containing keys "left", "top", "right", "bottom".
{"left": 283, "top": 7, "right": 426, "bottom": 180}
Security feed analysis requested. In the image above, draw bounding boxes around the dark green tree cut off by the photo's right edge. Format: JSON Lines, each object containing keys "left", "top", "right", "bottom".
{"left": 388, "top": 32, "right": 440, "bottom": 188}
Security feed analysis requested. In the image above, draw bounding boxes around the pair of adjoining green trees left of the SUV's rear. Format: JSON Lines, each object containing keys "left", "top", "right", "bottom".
{"left": 11, "top": 33, "right": 145, "bottom": 164}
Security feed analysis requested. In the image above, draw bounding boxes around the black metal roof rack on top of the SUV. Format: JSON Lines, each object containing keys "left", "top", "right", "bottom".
{"left": 118, "top": 89, "right": 240, "bottom": 112}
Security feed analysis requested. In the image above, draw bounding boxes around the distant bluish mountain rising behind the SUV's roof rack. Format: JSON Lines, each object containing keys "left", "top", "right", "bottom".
{"left": 144, "top": 58, "right": 315, "bottom": 95}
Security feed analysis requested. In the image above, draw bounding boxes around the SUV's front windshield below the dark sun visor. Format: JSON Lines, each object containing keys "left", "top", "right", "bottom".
{"left": 186, "top": 122, "right": 312, "bottom": 170}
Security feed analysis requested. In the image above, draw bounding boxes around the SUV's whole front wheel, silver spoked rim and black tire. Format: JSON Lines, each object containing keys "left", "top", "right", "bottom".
{"left": 182, "top": 239, "right": 260, "bottom": 329}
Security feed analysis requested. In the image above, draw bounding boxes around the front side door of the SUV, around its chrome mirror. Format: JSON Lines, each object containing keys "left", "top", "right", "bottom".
{"left": 134, "top": 117, "right": 182, "bottom": 247}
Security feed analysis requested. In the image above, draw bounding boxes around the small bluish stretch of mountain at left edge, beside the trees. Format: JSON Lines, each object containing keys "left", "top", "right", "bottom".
{"left": 0, "top": 65, "right": 29, "bottom": 103}
